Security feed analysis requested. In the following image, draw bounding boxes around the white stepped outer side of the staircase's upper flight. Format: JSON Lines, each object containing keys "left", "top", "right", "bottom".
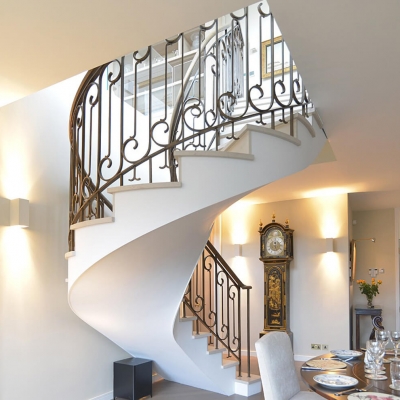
{"left": 67, "top": 120, "right": 326, "bottom": 288}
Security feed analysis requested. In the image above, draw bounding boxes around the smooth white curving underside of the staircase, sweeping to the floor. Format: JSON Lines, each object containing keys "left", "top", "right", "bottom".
{"left": 69, "top": 197, "right": 248, "bottom": 395}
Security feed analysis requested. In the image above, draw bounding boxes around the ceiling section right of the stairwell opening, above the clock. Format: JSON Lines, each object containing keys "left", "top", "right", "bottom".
{"left": 242, "top": 0, "right": 400, "bottom": 210}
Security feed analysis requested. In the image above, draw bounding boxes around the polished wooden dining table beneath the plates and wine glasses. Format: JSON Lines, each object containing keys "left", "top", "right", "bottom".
{"left": 300, "top": 353, "right": 400, "bottom": 400}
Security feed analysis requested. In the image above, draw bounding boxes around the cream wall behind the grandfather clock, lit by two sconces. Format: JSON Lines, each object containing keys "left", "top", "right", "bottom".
{"left": 222, "top": 195, "right": 350, "bottom": 359}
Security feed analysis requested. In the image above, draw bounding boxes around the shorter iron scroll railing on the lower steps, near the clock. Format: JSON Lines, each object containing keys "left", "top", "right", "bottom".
{"left": 183, "top": 242, "right": 251, "bottom": 376}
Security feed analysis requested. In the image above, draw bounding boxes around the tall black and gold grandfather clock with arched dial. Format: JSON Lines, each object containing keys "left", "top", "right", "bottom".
{"left": 259, "top": 214, "right": 293, "bottom": 342}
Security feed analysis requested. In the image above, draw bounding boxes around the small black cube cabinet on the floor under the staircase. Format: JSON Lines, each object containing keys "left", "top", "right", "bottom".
{"left": 114, "top": 358, "right": 153, "bottom": 400}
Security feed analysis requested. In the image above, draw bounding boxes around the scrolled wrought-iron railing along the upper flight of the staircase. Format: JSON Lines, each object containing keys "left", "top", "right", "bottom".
{"left": 69, "top": 2, "right": 311, "bottom": 250}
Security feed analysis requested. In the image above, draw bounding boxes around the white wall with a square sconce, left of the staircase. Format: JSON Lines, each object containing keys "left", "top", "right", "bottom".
{"left": 0, "top": 77, "right": 128, "bottom": 400}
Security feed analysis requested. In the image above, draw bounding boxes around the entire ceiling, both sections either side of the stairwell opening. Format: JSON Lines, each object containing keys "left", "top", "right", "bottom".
{"left": 0, "top": 0, "right": 400, "bottom": 209}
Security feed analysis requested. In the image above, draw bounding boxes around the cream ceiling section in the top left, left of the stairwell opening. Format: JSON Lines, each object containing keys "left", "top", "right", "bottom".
{"left": 0, "top": 0, "right": 253, "bottom": 107}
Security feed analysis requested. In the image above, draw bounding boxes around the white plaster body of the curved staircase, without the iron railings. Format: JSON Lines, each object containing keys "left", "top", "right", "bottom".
{"left": 69, "top": 120, "right": 325, "bottom": 394}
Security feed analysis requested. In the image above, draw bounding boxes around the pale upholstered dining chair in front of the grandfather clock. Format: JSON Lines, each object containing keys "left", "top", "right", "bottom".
{"left": 255, "top": 332, "right": 323, "bottom": 400}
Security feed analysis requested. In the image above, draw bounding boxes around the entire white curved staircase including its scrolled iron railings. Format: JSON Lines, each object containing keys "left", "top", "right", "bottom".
{"left": 66, "top": 2, "right": 325, "bottom": 396}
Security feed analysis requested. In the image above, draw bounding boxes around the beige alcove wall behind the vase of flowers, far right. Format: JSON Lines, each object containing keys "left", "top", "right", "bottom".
{"left": 353, "top": 209, "right": 398, "bottom": 346}
